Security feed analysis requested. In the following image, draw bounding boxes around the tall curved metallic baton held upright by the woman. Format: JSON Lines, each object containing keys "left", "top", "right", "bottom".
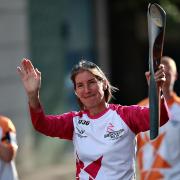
{"left": 147, "top": 3, "right": 166, "bottom": 140}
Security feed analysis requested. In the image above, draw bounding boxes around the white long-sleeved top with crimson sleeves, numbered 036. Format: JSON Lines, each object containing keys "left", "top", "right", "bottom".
{"left": 30, "top": 99, "right": 168, "bottom": 180}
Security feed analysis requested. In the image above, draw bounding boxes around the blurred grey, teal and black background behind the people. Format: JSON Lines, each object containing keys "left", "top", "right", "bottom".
{"left": 0, "top": 0, "right": 180, "bottom": 180}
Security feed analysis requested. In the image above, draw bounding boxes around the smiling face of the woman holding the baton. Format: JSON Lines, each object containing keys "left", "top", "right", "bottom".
{"left": 75, "top": 71, "right": 105, "bottom": 109}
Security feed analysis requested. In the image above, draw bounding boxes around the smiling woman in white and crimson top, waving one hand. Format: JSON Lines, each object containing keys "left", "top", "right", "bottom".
{"left": 18, "top": 59, "right": 169, "bottom": 180}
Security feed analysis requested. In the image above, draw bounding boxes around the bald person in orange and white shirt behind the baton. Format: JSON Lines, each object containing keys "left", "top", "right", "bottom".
{"left": 137, "top": 56, "right": 180, "bottom": 180}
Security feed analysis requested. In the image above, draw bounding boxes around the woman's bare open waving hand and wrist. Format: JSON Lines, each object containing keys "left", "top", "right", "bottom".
{"left": 17, "top": 58, "right": 41, "bottom": 108}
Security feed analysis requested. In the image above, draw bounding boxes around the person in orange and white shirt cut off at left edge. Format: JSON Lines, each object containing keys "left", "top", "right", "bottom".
{"left": 0, "top": 115, "right": 18, "bottom": 180}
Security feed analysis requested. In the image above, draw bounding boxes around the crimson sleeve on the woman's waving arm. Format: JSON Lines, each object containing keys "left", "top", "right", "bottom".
{"left": 29, "top": 106, "right": 74, "bottom": 140}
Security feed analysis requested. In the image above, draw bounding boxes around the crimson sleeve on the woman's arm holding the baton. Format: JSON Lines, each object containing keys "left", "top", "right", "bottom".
{"left": 118, "top": 98, "right": 169, "bottom": 134}
